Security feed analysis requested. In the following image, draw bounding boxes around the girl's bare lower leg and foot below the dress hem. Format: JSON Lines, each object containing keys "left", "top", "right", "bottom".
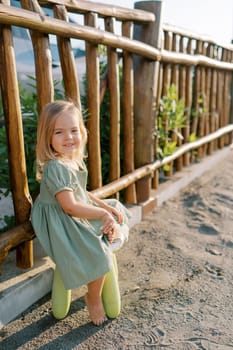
{"left": 85, "top": 276, "right": 107, "bottom": 326}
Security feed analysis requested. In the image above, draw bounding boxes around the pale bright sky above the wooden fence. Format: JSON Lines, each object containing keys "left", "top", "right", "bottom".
{"left": 95, "top": 0, "right": 233, "bottom": 44}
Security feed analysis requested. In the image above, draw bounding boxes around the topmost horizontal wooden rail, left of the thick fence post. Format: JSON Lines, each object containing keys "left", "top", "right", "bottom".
{"left": 39, "top": 0, "right": 155, "bottom": 23}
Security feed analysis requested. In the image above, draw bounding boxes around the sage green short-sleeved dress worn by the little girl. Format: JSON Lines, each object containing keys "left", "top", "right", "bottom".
{"left": 31, "top": 160, "right": 130, "bottom": 289}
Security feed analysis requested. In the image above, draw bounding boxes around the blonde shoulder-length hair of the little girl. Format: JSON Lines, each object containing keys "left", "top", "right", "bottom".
{"left": 36, "top": 100, "right": 87, "bottom": 180}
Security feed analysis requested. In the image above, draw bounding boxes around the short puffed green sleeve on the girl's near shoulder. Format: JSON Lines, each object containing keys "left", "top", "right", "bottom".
{"left": 43, "top": 160, "right": 77, "bottom": 196}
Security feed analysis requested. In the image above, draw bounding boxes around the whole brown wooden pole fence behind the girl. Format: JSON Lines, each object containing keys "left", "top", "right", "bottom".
{"left": 0, "top": 0, "right": 233, "bottom": 274}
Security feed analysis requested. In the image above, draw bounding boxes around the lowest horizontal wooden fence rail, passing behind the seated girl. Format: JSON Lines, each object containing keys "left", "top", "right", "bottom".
{"left": 0, "top": 124, "right": 233, "bottom": 274}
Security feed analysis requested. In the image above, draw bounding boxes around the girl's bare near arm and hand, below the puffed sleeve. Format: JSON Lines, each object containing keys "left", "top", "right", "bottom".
{"left": 56, "top": 190, "right": 116, "bottom": 241}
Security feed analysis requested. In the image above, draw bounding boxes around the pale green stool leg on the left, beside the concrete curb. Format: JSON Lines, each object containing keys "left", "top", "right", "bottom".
{"left": 52, "top": 267, "right": 71, "bottom": 320}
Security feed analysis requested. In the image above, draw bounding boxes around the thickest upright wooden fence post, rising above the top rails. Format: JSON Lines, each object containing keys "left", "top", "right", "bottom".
{"left": 134, "top": 1, "right": 163, "bottom": 202}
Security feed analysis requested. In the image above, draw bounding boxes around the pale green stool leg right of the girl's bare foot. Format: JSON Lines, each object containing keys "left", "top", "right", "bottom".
{"left": 102, "top": 254, "right": 121, "bottom": 318}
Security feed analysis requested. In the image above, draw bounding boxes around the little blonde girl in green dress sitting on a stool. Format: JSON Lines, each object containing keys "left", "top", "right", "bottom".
{"left": 31, "top": 101, "right": 130, "bottom": 325}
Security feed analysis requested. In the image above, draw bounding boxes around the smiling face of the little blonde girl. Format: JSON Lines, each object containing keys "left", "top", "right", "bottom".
{"left": 51, "top": 112, "right": 82, "bottom": 160}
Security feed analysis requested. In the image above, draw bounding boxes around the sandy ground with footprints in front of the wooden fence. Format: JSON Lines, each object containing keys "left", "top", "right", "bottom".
{"left": 0, "top": 153, "right": 233, "bottom": 350}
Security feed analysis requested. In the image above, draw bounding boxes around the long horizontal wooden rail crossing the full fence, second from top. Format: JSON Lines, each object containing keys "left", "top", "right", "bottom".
{"left": 0, "top": 4, "right": 233, "bottom": 71}
